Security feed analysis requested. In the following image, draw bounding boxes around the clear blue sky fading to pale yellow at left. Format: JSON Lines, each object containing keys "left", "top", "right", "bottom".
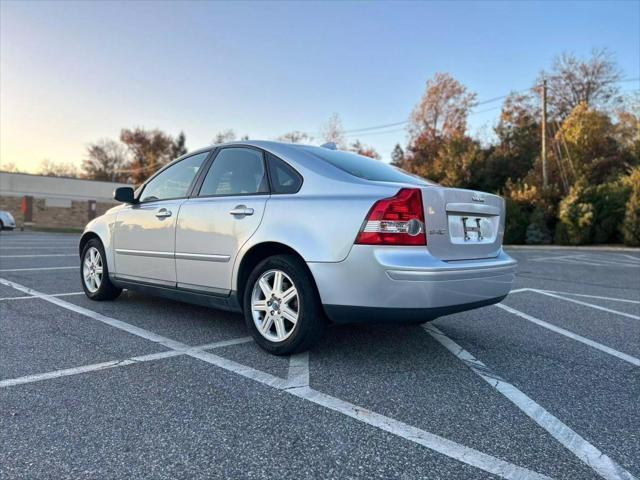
{"left": 0, "top": 0, "right": 640, "bottom": 170}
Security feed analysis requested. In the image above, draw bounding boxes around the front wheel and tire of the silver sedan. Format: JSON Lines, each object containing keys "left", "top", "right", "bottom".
{"left": 80, "top": 238, "right": 122, "bottom": 301}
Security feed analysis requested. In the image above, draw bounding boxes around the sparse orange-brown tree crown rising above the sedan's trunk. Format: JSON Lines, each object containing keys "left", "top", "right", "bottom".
{"left": 409, "top": 73, "right": 476, "bottom": 139}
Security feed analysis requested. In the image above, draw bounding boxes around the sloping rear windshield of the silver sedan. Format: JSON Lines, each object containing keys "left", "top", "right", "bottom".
{"left": 304, "top": 147, "right": 433, "bottom": 185}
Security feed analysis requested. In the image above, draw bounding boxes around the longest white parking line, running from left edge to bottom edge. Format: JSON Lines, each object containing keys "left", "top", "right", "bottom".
{"left": 0, "top": 278, "right": 549, "bottom": 480}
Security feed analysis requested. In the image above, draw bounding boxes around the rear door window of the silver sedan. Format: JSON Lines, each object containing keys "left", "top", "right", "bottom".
{"left": 198, "top": 147, "right": 269, "bottom": 197}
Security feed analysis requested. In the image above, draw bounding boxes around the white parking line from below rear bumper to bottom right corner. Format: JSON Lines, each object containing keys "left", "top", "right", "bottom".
{"left": 423, "top": 324, "right": 634, "bottom": 480}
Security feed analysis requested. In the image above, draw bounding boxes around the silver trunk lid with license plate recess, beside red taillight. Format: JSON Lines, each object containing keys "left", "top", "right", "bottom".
{"left": 421, "top": 186, "right": 505, "bottom": 260}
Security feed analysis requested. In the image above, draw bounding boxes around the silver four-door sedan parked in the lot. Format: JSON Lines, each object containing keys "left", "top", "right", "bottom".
{"left": 80, "top": 141, "right": 516, "bottom": 354}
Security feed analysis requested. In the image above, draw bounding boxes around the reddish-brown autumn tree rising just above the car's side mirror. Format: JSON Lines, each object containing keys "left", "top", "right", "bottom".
{"left": 120, "top": 128, "right": 175, "bottom": 184}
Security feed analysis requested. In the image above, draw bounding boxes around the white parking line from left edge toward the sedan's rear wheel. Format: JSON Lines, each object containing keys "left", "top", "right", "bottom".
{"left": 0, "top": 337, "right": 253, "bottom": 388}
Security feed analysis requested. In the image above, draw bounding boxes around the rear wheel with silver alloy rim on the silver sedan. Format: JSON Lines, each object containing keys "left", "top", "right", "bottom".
{"left": 243, "top": 255, "right": 326, "bottom": 355}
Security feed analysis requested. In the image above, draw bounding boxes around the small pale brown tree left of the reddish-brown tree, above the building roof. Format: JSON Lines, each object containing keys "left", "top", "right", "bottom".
{"left": 82, "top": 139, "right": 129, "bottom": 182}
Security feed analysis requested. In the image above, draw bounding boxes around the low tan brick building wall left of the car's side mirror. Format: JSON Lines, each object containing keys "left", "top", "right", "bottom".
{"left": 0, "top": 195, "right": 116, "bottom": 230}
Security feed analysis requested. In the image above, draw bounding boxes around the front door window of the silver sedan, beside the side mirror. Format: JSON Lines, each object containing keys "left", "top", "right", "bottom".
{"left": 140, "top": 152, "right": 209, "bottom": 202}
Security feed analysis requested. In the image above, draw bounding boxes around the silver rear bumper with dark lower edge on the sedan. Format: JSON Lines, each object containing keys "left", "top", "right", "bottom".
{"left": 308, "top": 245, "right": 517, "bottom": 323}
